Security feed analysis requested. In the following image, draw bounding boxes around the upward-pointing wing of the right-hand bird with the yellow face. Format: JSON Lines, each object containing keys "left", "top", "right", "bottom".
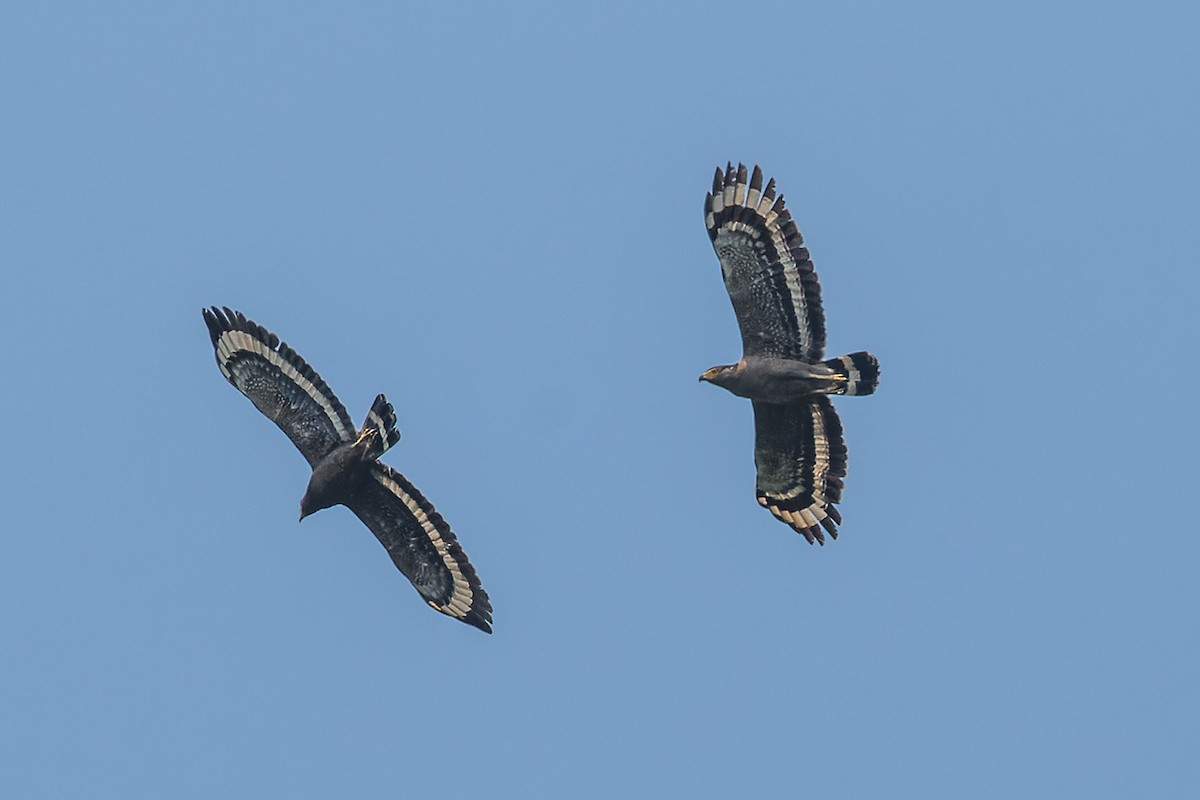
{"left": 704, "top": 164, "right": 824, "bottom": 361}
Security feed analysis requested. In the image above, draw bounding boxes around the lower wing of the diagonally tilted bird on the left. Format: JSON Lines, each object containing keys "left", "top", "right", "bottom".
{"left": 347, "top": 462, "right": 492, "bottom": 633}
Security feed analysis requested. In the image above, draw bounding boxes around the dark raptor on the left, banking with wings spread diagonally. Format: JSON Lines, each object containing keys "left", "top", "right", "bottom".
{"left": 203, "top": 306, "right": 492, "bottom": 633}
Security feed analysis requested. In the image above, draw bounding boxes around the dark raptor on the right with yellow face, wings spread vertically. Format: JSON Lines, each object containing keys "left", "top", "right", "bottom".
{"left": 700, "top": 164, "right": 880, "bottom": 545}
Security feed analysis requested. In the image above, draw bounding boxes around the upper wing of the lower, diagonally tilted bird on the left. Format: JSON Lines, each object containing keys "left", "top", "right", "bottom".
{"left": 204, "top": 306, "right": 355, "bottom": 467}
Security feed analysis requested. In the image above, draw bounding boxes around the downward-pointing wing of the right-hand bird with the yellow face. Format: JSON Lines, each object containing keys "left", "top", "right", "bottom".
{"left": 754, "top": 395, "right": 846, "bottom": 545}
